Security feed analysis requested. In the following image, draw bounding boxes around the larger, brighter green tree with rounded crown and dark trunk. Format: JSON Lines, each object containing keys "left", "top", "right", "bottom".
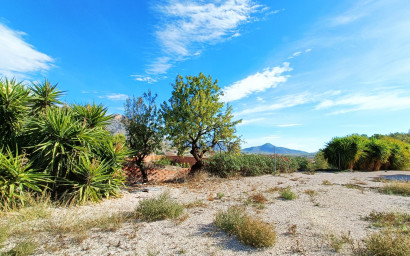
{"left": 161, "top": 73, "right": 241, "bottom": 172}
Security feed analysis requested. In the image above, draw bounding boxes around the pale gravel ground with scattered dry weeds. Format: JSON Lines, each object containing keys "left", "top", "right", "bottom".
{"left": 3, "top": 171, "right": 410, "bottom": 255}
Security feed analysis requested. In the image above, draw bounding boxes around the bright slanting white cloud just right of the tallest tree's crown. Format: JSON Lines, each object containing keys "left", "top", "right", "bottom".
{"left": 222, "top": 62, "right": 292, "bottom": 102}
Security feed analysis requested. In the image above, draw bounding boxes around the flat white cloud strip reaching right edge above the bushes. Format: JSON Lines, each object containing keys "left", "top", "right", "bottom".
{"left": 315, "top": 90, "right": 410, "bottom": 115}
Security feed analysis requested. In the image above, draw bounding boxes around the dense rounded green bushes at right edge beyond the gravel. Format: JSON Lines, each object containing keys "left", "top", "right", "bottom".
{"left": 323, "top": 134, "right": 410, "bottom": 171}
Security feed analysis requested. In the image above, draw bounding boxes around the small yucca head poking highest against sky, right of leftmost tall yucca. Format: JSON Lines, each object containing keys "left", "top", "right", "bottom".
{"left": 30, "top": 79, "right": 64, "bottom": 113}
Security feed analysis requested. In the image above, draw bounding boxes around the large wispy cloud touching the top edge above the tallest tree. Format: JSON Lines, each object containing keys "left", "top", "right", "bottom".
{"left": 157, "top": 0, "right": 261, "bottom": 56}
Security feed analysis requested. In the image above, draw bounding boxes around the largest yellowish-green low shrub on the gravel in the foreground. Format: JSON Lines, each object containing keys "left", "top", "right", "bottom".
{"left": 214, "top": 207, "right": 276, "bottom": 248}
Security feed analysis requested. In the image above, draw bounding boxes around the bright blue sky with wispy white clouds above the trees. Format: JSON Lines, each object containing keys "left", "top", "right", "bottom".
{"left": 0, "top": 0, "right": 410, "bottom": 152}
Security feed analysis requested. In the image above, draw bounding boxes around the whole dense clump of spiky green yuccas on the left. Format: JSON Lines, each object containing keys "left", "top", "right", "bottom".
{"left": 0, "top": 79, "right": 127, "bottom": 209}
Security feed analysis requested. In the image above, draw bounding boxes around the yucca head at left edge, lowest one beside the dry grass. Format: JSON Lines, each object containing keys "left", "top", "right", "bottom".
{"left": 0, "top": 149, "right": 51, "bottom": 209}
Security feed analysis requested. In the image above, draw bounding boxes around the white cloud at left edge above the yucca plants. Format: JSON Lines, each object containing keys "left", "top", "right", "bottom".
{"left": 0, "top": 23, "right": 54, "bottom": 76}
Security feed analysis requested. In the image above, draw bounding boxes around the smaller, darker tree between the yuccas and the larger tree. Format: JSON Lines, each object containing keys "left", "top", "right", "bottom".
{"left": 121, "top": 91, "right": 163, "bottom": 182}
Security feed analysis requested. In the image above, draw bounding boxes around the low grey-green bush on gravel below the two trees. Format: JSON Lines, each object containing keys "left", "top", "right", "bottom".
{"left": 136, "top": 192, "right": 184, "bottom": 221}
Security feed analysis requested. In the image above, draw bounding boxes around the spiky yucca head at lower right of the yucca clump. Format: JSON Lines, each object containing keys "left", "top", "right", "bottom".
{"left": 70, "top": 154, "right": 123, "bottom": 204}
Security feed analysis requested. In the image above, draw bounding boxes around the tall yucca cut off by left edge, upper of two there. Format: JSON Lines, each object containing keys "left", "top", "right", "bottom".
{"left": 0, "top": 78, "right": 30, "bottom": 149}
